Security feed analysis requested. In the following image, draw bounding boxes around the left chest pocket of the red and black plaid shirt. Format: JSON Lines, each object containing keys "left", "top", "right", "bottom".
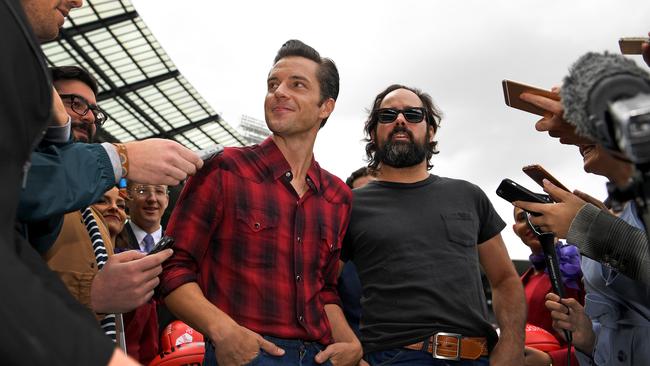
{"left": 232, "top": 208, "right": 279, "bottom": 268}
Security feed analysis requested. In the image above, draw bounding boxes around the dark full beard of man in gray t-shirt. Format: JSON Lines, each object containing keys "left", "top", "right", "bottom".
{"left": 375, "top": 126, "right": 428, "bottom": 168}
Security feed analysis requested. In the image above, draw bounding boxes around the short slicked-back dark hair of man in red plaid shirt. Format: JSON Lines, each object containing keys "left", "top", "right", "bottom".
{"left": 273, "top": 39, "right": 339, "bottom": 128}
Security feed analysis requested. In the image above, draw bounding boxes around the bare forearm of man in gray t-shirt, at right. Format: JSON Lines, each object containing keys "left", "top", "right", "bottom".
{"left": 492, "top": 276, "right": 526, "bottom": 352}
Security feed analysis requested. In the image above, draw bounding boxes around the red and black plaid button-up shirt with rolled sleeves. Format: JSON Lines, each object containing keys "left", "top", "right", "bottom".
{"left": 160, "top": 138, "right": 352, "bottom": 344}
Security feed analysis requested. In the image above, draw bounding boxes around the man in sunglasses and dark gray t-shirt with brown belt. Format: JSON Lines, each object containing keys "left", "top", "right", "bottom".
{"left": 341, "top": 85, "right": 526, "bottom": 365}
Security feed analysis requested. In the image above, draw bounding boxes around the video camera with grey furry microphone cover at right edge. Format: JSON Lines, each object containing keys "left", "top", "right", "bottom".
{"left": 560, "top": 52, "right": 650, "bottom": 163}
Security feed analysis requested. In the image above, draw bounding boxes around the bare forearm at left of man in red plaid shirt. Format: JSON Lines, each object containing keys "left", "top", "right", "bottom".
{"left": 165, "top": 282, "right": 238, "bottom": 341}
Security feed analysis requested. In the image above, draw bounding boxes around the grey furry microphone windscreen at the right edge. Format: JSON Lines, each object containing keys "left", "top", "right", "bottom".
{"left": 560, "top": 52, "right": 650, "bottom": 141}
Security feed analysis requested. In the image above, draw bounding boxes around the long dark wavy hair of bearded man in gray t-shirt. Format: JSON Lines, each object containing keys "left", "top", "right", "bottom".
{"left": 363, "top": 84, "right": 442, "bottom": 170}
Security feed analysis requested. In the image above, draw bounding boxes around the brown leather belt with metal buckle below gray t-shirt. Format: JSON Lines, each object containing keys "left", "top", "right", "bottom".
{"left": 404, "top": 333, "right": 488, "bottom": 361}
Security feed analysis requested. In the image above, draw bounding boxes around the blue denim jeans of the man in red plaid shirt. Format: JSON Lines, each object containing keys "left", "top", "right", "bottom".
{"left": 203, "top": 336, "right": 332, "bottom": 366}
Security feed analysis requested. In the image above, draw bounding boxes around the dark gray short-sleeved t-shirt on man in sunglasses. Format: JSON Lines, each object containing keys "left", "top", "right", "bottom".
{"left": 341, "top": 175, "right": 505, "bottom": 352}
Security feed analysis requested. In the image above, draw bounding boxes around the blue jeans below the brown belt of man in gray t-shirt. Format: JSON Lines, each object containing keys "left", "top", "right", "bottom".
{"left": 364, "top": 348, "right": 490, "bottom": 366}
